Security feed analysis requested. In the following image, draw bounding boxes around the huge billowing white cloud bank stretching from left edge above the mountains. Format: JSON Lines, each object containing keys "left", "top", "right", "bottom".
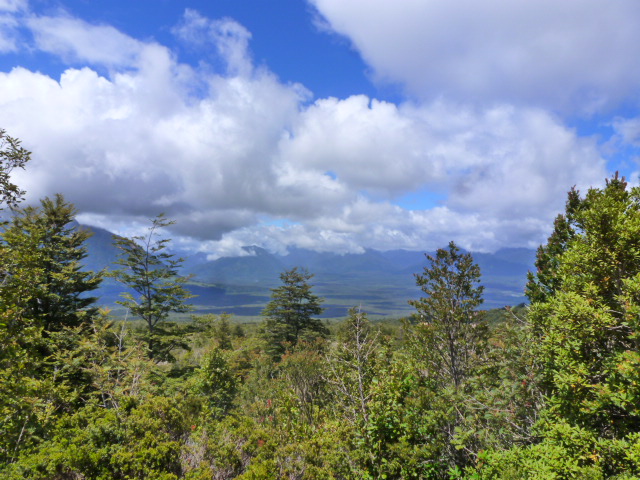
{"left": 0, "top": 5, "right": 606, "bottom": 256}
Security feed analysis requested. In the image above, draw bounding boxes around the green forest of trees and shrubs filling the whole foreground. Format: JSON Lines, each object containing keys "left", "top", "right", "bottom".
{"left": 0, "top": 130, "right": 640, "bottom": 480}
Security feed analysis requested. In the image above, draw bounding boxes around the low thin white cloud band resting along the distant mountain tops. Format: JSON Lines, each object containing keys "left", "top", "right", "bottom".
{"left": 200, "top": 203, "right": 550, "bottom": 259}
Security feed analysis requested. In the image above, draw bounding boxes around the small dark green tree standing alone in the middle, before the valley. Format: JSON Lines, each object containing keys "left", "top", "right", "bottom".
{"left": 262, "top": 267, "right": 327, "bottom": 354}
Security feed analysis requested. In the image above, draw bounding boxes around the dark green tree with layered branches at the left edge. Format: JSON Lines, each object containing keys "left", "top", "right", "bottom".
{"left": 0, "top": 194, "right": 102, "bottom": 332}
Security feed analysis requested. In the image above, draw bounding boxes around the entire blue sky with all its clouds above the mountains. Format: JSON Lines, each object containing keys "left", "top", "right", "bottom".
{"left": 0, "top": 0, "right": 640, "bottom": 258}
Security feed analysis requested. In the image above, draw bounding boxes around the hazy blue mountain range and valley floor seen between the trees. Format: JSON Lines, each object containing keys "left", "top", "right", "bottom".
{"left": 83, "top": 227, "right": 535, "bottom": 317}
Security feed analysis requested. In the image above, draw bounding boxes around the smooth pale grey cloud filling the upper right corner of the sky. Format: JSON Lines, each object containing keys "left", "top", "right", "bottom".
{"left": 310, "top": 0, "right": 640, "bottom": 113}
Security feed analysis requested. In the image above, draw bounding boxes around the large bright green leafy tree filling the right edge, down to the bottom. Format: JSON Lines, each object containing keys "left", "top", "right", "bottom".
{"left": 481, "top": 173, "right": 640, "bottom": 478}
